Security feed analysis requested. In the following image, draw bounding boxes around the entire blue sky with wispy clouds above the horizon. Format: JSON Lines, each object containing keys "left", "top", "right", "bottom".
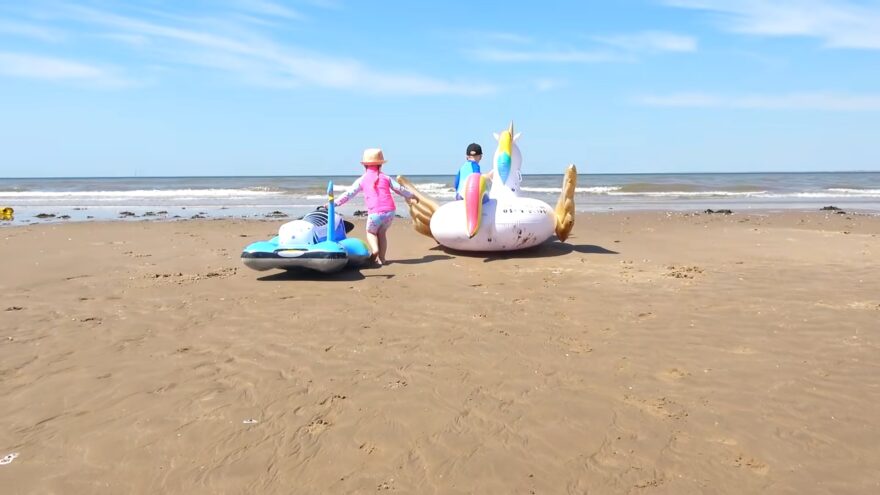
{"left": 0, "top": 0, "right": 880, "bottom": 177}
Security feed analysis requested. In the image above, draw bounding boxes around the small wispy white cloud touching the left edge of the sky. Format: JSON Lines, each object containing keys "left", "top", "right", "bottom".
{"left": 0, "top": 52, "right": 130, "bottom": 88}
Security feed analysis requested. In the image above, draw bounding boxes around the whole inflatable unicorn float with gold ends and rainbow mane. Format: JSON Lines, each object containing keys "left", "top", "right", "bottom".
{"left": 397, "top": 122, "right": 577, "bottom": 251}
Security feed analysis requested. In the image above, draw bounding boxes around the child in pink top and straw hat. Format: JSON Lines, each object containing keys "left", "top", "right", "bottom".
{"left": 334, "top": 148, "right": 419, "bottom": 265}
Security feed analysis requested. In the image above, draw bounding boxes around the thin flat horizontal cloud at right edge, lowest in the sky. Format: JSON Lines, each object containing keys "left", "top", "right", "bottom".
{"left": 635, "top": 93, "right": 880, "bottom": 112}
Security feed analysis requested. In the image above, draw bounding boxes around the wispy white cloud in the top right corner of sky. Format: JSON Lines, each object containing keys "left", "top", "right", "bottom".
{"left": 662, "top": 0, "right": 880, "bottom": 50}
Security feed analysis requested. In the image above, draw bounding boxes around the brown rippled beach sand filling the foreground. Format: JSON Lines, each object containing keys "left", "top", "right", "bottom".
{"left": 0, "top": 212, "right": 880, "bottom": 495}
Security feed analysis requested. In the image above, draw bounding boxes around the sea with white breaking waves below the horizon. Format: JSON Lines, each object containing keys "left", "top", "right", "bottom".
{"left": 0, "top": 172, "right": 880, "bottom": 225}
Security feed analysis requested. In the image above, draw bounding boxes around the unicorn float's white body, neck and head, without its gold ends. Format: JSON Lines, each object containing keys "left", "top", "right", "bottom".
{"left": 430, "top": 123, "right": 556, "bottom": 251}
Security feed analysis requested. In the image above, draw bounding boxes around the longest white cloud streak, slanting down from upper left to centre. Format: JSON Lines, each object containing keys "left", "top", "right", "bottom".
{"left": 57, "top": 7, "right": 495, "bottom": 95}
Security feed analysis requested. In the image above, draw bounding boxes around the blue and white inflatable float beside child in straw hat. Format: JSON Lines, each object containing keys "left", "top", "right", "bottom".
{"left": 241, "top": 182, "right": 372, "bottom": 273}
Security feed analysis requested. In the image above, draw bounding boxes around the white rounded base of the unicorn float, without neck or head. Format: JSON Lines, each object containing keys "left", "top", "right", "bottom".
{"left": 431, "top": 198, "right": 556, "bottom": 251}
